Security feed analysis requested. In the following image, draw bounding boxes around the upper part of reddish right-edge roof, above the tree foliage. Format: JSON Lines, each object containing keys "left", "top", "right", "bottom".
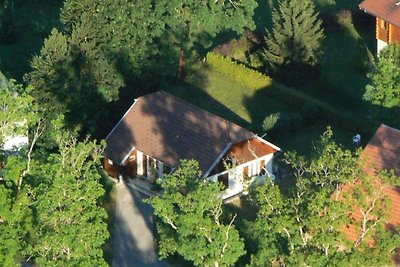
{"left": 362, "top": 124, "right": 400, "bottom": 176}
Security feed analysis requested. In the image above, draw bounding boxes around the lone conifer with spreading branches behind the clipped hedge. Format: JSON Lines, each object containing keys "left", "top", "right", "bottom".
{"left": 264, "top": 0, "right": 324, "bottom": 83}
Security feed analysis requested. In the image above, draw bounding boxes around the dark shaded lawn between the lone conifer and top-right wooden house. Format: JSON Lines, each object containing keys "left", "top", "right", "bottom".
{"left": 302, "top": 11, "right": 374, "bottom": 114}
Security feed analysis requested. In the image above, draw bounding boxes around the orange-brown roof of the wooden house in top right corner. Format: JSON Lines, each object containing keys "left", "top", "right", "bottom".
{"left": 359, "top": 0, "right": 400, "bottom": 27}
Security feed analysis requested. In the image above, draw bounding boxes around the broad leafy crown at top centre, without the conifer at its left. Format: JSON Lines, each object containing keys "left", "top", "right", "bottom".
{"left": 61, "top": 0, "right": 257, "bottom": 81}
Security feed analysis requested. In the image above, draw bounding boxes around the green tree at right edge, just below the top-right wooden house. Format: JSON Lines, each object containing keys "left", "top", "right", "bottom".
{"left": 364, "top": 44, "right": 400, "bottom": 108}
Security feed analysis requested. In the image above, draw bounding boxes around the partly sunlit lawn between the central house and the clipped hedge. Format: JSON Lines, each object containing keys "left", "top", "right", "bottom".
{"left": 167, "top": 63, "right": 355, "bottom": 155}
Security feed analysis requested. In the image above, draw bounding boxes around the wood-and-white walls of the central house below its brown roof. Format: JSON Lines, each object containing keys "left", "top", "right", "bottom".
{"left": 103, "top": 138, "right": 279, "bottom": 199}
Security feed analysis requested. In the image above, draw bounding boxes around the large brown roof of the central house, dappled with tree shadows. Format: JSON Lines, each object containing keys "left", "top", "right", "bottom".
{"left": 105, "top": 91, "right": 254, "bottom": 171}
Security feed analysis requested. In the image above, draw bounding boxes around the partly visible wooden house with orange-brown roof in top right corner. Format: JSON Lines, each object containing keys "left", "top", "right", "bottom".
{"left": 359, "top": 0, "right": 400, "bottom": 53}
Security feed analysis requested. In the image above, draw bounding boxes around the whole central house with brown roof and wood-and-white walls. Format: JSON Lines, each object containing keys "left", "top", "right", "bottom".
{"left": 103, "top": 91, "right": 280, "bottom": 199}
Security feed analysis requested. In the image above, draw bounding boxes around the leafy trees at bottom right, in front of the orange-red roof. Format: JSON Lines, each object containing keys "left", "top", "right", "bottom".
{"left": 248, "top": 128, "right": 400, "bottom": 266}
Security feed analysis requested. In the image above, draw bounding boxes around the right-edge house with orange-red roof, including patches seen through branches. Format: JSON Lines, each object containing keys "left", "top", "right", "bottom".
{"left": 342, "top": 124, "right": 400, "bottom": 265}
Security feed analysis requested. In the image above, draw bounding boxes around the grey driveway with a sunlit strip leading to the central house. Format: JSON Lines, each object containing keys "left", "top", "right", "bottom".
{"left": 112, "top": 184, "right": 169, "bottom": 267}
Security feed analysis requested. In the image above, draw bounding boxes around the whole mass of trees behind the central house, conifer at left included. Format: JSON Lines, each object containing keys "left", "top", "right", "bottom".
{"left": 25, "top": 0, "right": 256, "bottom": 138}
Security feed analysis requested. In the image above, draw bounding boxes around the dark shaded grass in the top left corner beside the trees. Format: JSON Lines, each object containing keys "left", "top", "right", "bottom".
{"left": 0, "top": 0, "right": 63, "bottom": 82}
